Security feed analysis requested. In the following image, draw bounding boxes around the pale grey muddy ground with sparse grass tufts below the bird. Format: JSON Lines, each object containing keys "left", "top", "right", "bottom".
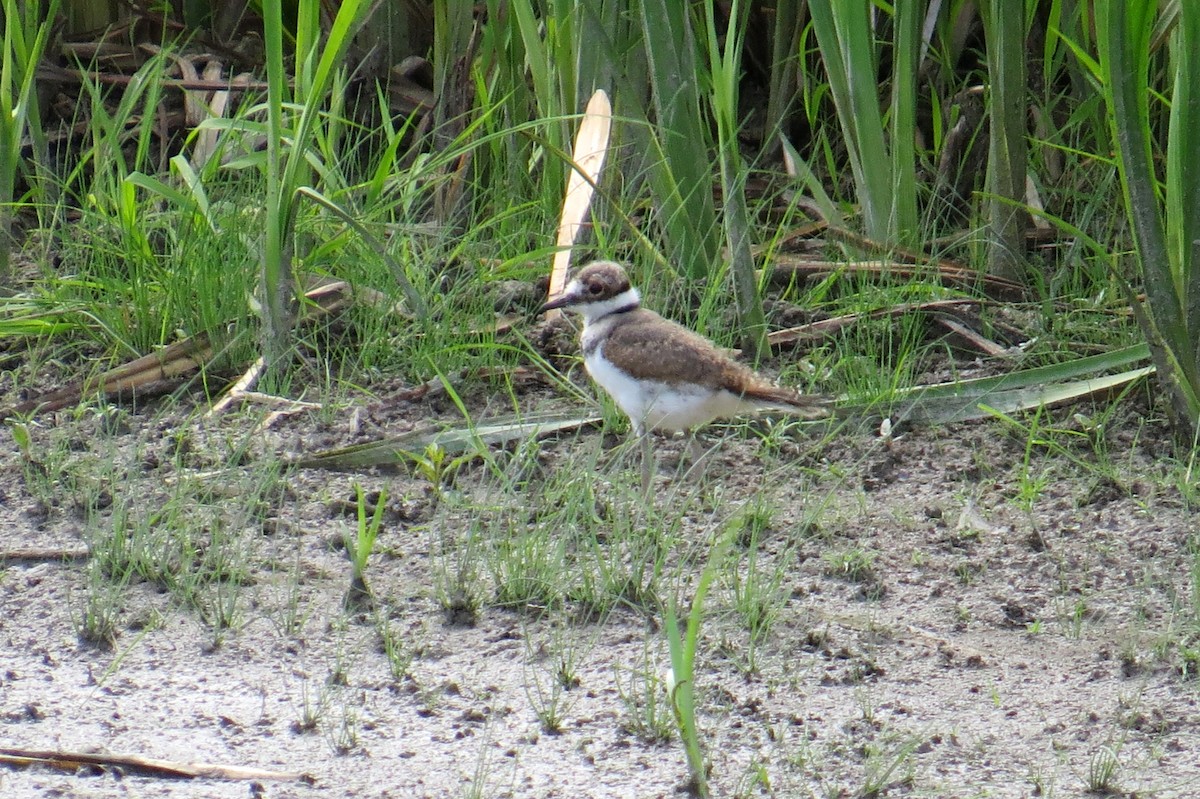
{"left": 0, "top": 364, "right": 1200, "bottom": 799}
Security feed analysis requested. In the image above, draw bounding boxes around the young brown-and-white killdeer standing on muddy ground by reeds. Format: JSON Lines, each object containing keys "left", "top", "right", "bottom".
{"left": 541, "top": 260, "right": 829, "bottom": 488}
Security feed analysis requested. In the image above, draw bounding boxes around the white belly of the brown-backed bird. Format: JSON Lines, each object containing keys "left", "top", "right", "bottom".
{"left": 584, "top": 346, "right": 752, "bottom": 433}
